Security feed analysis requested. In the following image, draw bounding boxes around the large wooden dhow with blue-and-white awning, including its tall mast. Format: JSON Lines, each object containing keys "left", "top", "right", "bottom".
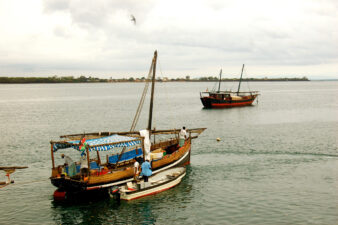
{"left": 50, "top": 51, "right": 206, "bottom": 195}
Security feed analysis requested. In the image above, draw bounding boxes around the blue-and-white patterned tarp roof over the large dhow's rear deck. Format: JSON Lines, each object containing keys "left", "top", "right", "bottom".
{"left": 53, "top": 134, "right": 141, "bottom": 152}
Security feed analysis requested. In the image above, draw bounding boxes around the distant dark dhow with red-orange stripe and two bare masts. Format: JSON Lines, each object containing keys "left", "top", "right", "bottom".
{"left": 200, "top": 64, "right": 259, "bottom": 108}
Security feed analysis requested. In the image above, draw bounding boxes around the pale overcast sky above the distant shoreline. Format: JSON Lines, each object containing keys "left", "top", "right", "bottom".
{"left": 0, "top": 0, "right": 338, "bottom": 78}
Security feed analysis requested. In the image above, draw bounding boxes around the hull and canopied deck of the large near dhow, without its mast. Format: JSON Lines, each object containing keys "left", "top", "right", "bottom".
{"left": 50, "top": 128, "right": 205, "bottom": 191}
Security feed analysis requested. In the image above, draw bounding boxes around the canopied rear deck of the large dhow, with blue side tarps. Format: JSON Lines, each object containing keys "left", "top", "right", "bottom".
{"left": 51, "top": 134, "right": 143, "bottom": 180}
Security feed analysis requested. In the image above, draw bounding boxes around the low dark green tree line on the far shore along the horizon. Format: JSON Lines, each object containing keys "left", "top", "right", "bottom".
{"left": 0, "top": 76, "right": 309, "bottom": 84}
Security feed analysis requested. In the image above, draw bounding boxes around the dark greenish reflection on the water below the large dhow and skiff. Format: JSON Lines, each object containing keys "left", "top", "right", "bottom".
{"left": 52, "top": 166, "right": 193, "bottom": 224}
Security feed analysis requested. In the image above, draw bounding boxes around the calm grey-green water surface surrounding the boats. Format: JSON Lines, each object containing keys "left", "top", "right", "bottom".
{"left": 0, "top": 81, "right": 338, "bottom": 224}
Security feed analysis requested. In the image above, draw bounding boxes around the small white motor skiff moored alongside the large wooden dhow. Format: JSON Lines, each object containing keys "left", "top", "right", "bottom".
{"left": 118, "top": 167, "right": 186, "bottom": 201}
